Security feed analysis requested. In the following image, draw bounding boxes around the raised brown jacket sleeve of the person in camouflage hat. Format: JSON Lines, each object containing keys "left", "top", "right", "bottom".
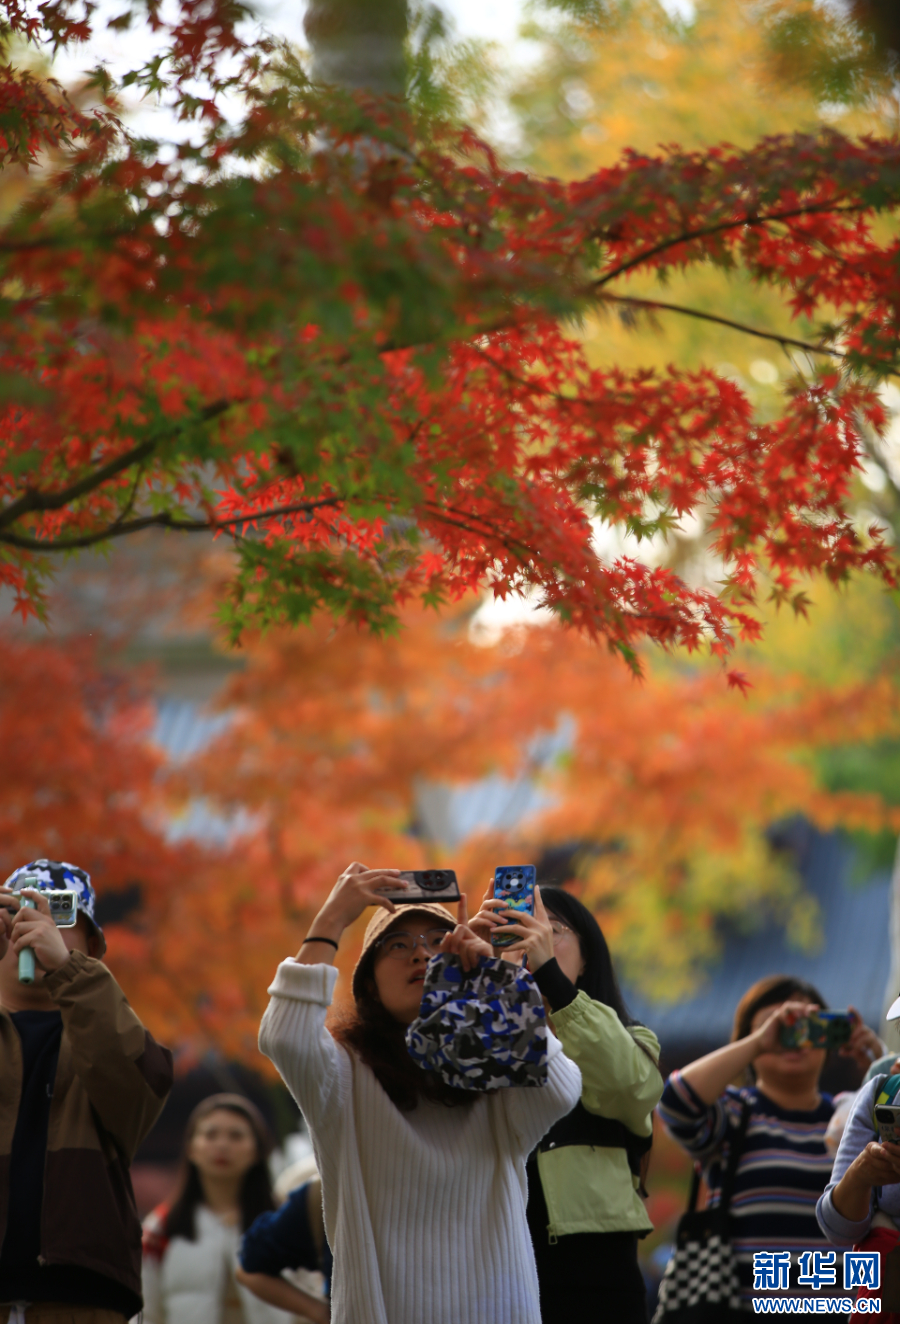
{"left": 44, "top": 952, "right": 172, "bottom": 1161}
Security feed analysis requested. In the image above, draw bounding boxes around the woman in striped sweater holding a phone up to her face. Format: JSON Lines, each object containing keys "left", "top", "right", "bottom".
{"left": 659, "top": 974, "right": 884, "bottom": 1320}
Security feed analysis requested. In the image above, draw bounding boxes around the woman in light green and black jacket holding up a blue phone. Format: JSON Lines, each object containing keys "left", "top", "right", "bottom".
{"left": 478, "top": 887, "right": 663, "bottom": 1324}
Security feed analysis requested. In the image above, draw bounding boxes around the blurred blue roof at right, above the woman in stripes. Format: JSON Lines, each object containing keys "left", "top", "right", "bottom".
{"left": 623, "top": 821, "right": 900, "bottom": 1053}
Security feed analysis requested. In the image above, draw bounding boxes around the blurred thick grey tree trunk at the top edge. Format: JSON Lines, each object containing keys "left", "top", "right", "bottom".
{"left": 303, "top": 0, "right": 409, "bottom": 97}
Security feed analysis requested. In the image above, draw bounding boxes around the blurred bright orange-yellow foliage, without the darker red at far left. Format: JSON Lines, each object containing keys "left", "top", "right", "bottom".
{"left": 146, "top": 609, "right": 900, "bottom": 1057}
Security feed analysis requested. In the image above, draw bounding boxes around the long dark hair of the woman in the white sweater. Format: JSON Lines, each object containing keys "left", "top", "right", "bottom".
{"left": 330, "top": 947, "right": 476, "bottom": 1112}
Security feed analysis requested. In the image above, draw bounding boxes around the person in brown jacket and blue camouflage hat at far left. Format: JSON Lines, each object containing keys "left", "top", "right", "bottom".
{"left": 0, "top": 859, "right": 172, "bottom": 1324}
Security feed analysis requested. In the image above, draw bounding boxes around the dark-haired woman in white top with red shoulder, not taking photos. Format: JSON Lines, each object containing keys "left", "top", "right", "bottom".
{"left": 143, "top": 1094, "right": 291, "bottom": 1324}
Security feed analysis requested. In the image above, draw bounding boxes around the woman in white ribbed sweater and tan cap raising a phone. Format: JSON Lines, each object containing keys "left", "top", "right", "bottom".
{"left": 259, "top": 865, "right": 581, "bottom": 1324}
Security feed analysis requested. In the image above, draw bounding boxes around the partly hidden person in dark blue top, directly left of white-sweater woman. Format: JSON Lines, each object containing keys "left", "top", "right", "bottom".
{"left": 237, "top": 1156, "right": 332, "bottom": 1324}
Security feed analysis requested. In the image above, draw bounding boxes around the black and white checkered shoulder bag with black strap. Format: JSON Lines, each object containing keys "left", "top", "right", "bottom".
{"left": 653, "top": 1103, "right": 750, "bottom": 1324}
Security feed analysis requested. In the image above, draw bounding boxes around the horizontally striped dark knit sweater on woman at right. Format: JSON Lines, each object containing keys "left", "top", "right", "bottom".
{"left": 658, "top": 1071, "right": 843, "bottom": 1309}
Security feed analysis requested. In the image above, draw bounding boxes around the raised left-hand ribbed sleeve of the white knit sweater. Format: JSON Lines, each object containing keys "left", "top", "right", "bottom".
{"left": 259, "top": 960, "right": 349, "bottom": 1129}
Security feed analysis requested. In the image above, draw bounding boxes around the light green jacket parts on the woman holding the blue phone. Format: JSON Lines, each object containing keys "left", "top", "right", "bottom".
{"left": 537, "top": 992, "right": 663, "bottom": 1242}
